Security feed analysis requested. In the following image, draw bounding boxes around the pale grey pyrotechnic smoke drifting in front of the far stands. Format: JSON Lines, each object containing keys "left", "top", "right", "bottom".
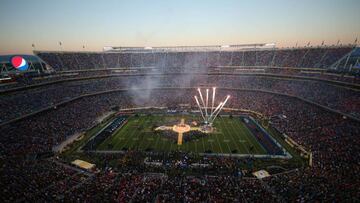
{"left": 130, "top": 52, "right": 207, "bottom": 105}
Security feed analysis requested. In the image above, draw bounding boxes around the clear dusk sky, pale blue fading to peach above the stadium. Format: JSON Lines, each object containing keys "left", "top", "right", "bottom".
{"left": 0, "top": 0, "right": 360, "bottom": 54}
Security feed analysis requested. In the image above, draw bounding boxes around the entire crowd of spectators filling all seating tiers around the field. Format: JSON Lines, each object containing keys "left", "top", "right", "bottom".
{"left": 0, "top": 47, "right": 360, "bottom": 202}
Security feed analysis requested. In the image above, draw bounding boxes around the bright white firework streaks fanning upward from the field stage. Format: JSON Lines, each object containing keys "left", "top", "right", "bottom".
{"left": 194, "top": 87, "right": 230, "bottom": 126}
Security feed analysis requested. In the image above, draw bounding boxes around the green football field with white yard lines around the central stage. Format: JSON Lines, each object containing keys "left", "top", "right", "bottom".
{"left": 97, "top": 115, "right": 266, "bottom": 154}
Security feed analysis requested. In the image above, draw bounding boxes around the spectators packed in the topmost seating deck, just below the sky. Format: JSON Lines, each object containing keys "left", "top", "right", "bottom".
{"left": 0, "top": 46, "right": 359, "bottom": 90}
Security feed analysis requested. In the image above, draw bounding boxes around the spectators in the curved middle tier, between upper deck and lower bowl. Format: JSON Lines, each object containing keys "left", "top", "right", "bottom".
{"left": 0, "top": 74, "right": 360, "bottom": 123}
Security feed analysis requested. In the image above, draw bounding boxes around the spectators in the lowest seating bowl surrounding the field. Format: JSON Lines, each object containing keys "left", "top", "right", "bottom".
{"left": 0, "top": 89, "right": 360, "bottom": 202}
